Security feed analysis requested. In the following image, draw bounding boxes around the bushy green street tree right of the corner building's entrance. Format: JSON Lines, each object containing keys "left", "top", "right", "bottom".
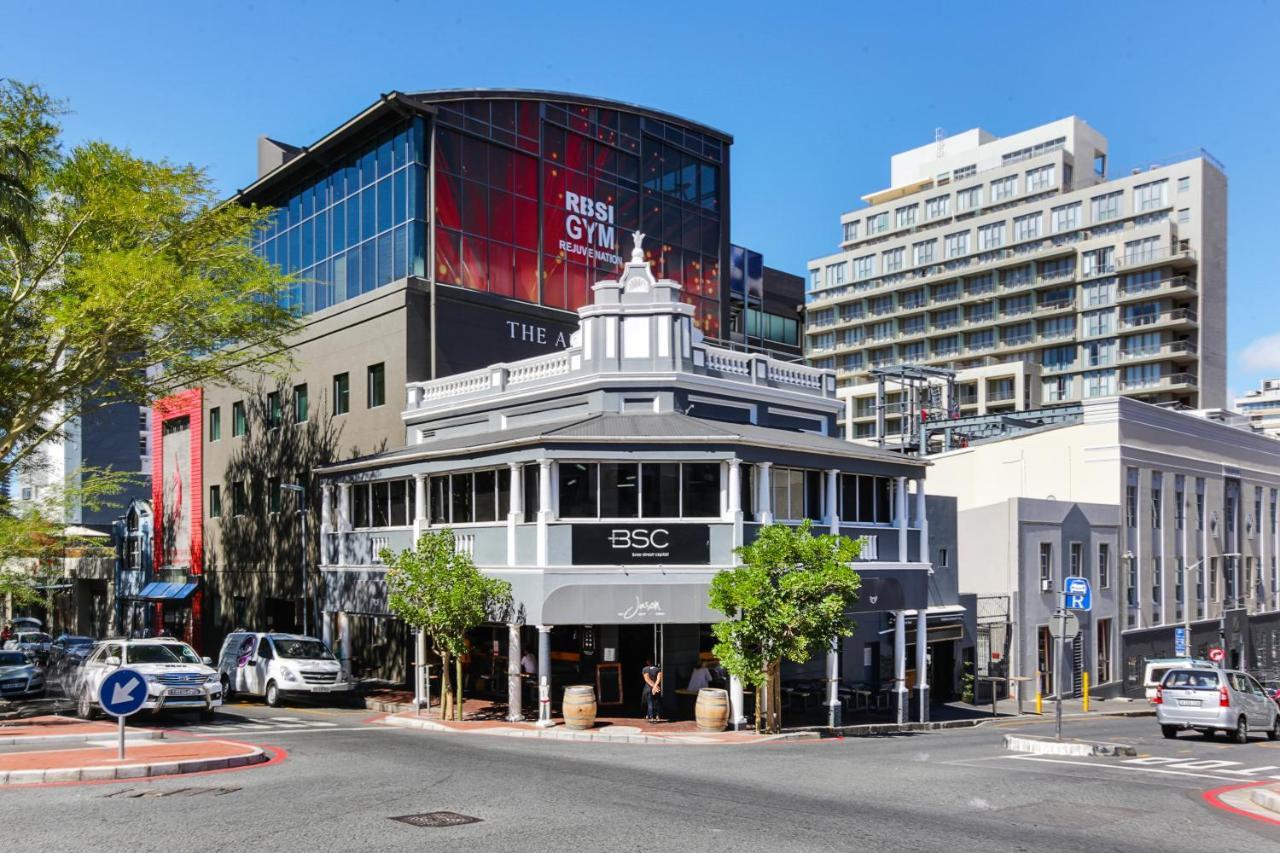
{"left": 710, "top": 521, "right": 861, "bottom": 731}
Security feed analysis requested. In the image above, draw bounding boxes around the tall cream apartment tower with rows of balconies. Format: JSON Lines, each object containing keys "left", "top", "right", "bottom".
{"left": 805, "top": 117, "right": 1226, "bottom": 437}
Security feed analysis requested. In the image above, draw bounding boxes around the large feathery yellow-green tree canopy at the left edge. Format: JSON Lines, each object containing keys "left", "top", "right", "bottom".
{"left": 0, "top": 79, "right": 296, "bottom": 491}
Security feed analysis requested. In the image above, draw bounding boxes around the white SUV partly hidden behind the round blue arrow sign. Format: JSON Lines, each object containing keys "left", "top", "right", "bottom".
{"left": 72, "top": 637, "right": 223, "bottom": 720}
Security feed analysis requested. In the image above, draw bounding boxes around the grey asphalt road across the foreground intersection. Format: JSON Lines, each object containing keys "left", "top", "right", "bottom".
{"left": 0, "top": 704, "right": 1280, "bottom": 853}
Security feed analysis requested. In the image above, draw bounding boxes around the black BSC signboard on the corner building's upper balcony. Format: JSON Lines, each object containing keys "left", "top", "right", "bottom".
{"left": 573, "top": 523, "right": 712, "bottom": 566}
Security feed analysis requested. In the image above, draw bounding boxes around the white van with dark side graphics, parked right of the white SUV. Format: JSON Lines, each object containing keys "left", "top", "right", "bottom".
{"left": 218, "top": 631, "right": 353, "bottom": 708}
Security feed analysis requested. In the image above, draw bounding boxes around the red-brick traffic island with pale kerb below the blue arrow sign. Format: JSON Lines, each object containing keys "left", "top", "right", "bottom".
{"left": 0, "top": 717, "right": 273, "bottom": 785}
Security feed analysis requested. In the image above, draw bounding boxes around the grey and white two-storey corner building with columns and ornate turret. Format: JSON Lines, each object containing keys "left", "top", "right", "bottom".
{"left": 319, "top": 236, "right": 947, "bottom": 720}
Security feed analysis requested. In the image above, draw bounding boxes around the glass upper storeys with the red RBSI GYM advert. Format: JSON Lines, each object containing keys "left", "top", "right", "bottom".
{"left": 241, "top": 92, "right": 732, "bottom": 337}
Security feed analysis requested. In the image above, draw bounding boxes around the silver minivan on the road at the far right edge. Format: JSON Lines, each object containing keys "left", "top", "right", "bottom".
{"left": 1152, "top": 667, "right": 1280, "bottom": 743}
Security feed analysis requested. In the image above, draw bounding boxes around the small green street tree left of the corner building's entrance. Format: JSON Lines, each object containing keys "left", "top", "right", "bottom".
{"left": 381, "top": 529, "right": 512, "bottom": 720}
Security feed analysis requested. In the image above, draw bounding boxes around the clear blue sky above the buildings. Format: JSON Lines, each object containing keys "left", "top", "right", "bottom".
{"left": 0, "top": 0, "right": 1280, "bottom": 399}
